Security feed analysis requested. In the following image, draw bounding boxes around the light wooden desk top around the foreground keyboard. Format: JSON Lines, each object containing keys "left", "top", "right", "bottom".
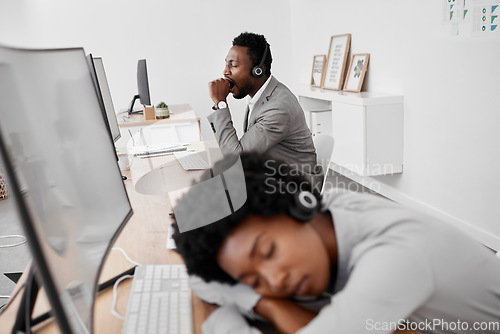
{"left": 0, "top": 143, "right": 217, "bottom": 334}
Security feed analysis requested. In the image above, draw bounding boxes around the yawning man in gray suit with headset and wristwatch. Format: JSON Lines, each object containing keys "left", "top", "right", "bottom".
{"left": 208, "top": 32, "right": 316, "bottom": 174}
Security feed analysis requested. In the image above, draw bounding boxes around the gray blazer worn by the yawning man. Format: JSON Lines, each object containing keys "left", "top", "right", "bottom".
{"left": 208, "top": 77, "right": 316, "bottom": 174}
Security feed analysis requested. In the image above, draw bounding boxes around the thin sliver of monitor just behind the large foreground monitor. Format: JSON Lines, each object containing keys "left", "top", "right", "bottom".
{"left": 87, "top": 54, "right": 121, "bottom": 143}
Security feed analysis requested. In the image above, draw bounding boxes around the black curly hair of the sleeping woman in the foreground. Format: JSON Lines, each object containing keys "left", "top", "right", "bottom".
{"left": 172, "top": 152, "right": 321, "bottom": 284}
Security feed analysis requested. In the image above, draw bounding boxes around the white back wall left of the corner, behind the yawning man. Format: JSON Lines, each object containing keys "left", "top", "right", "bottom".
{"left": 0, "top": 0, "right": 291, "bottom": 138}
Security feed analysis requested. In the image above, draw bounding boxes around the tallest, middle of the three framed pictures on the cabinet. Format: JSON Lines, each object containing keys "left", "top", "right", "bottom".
{"left": 321, "top": 34, "right": 351, "bottom": 90}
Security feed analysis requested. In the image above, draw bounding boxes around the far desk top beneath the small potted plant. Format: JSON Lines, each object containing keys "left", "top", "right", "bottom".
{"left": 117, "top": 104, "right": 200, "bottom": 127}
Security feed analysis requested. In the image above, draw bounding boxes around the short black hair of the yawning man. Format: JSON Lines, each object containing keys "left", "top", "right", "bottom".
{"left": 233, "top": 32, "right": 273, "bottom": 77}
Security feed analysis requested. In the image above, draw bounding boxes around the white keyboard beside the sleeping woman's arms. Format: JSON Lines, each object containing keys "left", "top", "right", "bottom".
{"left": 122, "top": 265, "right": 193, "bottom": 334}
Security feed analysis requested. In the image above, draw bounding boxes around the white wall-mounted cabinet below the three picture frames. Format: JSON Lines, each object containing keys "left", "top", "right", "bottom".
{"left": 296, "top": 86, "right": 403, "bottom": 176}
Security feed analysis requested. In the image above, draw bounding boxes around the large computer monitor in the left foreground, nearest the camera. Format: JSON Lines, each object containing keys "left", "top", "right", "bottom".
{"left": 0, "top": 46, "right": 132, "bottom": 333}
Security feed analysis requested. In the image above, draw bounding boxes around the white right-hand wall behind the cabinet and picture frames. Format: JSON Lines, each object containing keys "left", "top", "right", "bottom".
{"left": 291, "top": 0, "right": 500, "bottom": 249}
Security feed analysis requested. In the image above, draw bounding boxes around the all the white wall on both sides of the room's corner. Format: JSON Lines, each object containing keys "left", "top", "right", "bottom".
{"left": 0, "top": 0, "right": 500, "bottom": 249}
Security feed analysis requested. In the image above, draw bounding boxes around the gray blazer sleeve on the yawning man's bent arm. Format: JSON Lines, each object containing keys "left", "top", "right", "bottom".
{"left": 208, "top": 103, "right": 290, "bottom": 154}
